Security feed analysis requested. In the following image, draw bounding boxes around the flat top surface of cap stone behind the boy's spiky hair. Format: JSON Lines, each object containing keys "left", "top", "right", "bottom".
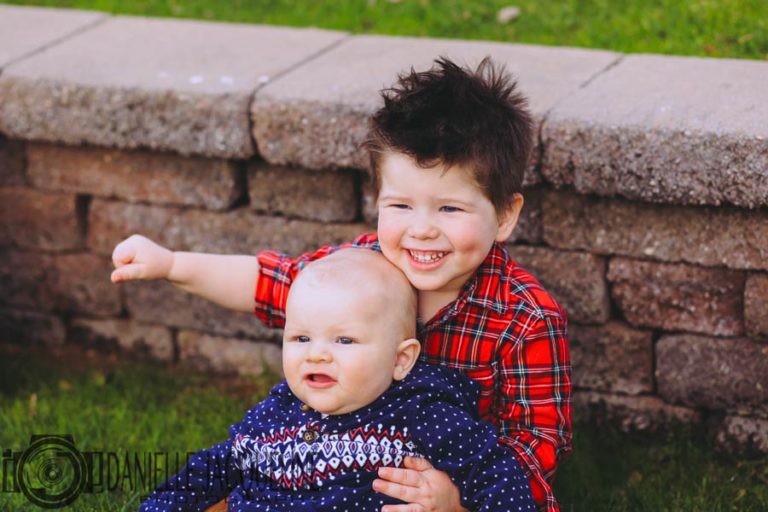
{"left": 257, "top": 35, "right": 620, "bottom": 115}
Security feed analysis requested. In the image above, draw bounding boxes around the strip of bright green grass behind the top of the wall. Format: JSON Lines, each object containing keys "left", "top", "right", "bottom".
{"left": 4, "top": 0, "right": 768, "bottom": 59}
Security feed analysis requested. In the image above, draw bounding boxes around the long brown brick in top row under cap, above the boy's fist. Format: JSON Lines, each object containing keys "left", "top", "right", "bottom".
{"left": 27, "top": 144, "right": 243, "bottom": 210}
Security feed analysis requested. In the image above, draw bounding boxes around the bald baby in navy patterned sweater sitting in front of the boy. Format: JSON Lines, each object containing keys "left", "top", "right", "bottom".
{"left": 141, "top": 249, "right": 535, "bottom": 512}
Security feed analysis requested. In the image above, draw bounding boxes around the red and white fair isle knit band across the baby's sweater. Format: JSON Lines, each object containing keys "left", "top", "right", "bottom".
{"left": 232, "top": 422, "right": 421, "bottom": 490}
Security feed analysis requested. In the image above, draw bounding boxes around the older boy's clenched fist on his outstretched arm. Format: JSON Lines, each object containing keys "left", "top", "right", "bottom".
{"left": 111, "top": 235, "right": 174, "bottom": 283}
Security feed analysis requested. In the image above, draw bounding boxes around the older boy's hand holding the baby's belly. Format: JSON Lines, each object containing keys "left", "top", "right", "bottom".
{"left": 373, "top": 457, "right": 466, "bottom": 512}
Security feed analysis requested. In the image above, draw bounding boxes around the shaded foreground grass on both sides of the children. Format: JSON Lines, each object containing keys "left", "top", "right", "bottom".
{"left": 0, "top": 351, "right": 768, "bottom": 512}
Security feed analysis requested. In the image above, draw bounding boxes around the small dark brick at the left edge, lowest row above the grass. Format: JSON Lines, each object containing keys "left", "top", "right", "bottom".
{"left": 0, "top": 309, "right": 67, "bottom": 346}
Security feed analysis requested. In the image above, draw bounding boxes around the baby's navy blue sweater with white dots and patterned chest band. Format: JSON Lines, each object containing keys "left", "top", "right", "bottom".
{"left": 140, "top": 363, "right": 536, "bottom": 512}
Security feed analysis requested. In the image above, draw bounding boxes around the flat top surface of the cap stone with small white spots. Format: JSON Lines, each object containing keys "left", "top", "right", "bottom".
{"left": 0, "top": 16, "right": 346, "bottom": 94}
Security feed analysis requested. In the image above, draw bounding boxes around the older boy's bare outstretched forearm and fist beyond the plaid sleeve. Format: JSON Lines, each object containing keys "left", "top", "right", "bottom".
{"left": 112, "top": 235, "right": 259, "bottom": 312}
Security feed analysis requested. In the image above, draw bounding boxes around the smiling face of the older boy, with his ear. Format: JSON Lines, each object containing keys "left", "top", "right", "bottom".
{"left": 378, "top": 152, "right": 522, "bottom": 303}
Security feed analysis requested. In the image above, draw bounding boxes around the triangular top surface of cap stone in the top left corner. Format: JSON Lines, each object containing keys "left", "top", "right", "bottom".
{"left": 0, "top": 5, "right": 107, "bottom": 68}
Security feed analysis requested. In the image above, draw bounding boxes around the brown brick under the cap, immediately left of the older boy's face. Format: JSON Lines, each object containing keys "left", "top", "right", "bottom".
{"left": 248, "top": 163, "right": 358, "bottom": 222}
